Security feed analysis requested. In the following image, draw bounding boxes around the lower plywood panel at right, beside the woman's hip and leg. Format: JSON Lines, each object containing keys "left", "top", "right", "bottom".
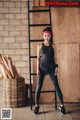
{"left": 60, "top": 44, "right": 80, "bottom": 102}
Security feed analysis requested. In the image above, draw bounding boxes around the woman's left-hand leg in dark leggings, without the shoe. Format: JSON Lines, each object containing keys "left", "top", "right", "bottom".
{"left": 35, "top": 73, "right": 45, "bottom": 106}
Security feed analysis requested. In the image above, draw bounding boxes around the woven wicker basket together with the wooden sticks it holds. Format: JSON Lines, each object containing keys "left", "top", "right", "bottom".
{"left": 0, "top": 54, "right": 26, "bottom": 108}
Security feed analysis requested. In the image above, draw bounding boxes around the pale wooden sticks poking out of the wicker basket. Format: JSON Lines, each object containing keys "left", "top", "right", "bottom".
{"left": 0, "top": 54, "right": 19, "bottom": 79}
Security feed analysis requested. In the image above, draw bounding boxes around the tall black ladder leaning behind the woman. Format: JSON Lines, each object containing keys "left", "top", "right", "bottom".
{"left": 28, "top": 0, "right": 57, "bottom": 110}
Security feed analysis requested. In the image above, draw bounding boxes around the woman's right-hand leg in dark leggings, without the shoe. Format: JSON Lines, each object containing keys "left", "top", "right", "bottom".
{"left": 49, "top": 72, "right": 63, "bottom": 105}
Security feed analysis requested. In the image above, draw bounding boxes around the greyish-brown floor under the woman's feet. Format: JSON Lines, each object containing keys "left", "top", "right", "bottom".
{"left": 0, "top": 100, "right": 80, "bottom": 120}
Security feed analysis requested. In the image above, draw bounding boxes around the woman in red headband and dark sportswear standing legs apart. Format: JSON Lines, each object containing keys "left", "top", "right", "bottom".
{"left": 34, "top": 27, "right": 65, "bottom": 114}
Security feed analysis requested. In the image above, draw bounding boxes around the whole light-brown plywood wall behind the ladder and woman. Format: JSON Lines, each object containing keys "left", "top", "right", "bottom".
{"left": 33, "top": 8, "right": 80, "bottom": 102}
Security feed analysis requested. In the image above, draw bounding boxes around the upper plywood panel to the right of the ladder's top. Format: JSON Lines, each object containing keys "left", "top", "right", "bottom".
{"left": 51, "top": 8, "right": 80, "bottom": 43}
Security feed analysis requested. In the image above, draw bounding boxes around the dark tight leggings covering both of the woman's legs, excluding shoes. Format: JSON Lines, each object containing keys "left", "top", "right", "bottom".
{"left": 35, "top": 71, "right": 63, "bottom": 105}
